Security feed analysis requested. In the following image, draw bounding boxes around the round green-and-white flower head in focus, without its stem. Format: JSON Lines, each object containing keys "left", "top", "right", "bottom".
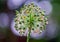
{"left": 14, "top": 2, "right": 48, "bottom": 36}
